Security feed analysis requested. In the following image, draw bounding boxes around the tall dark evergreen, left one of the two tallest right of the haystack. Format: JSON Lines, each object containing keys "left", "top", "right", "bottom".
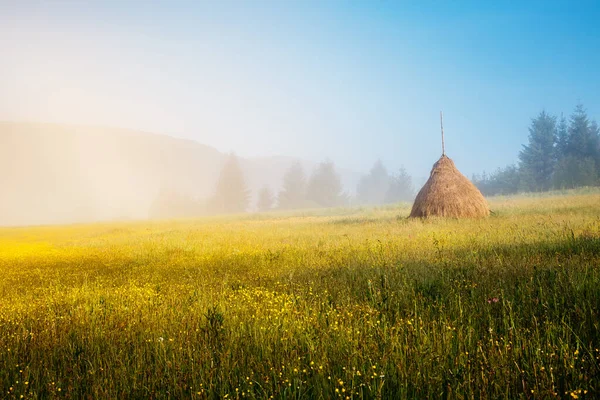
{"left": 519, "top": 111, "right": 557, "bottom": 190}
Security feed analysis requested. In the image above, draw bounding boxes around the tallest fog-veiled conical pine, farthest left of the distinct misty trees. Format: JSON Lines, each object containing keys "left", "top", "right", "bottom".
{"left": 212, "top": 154, "right": 250, "bottom": 213}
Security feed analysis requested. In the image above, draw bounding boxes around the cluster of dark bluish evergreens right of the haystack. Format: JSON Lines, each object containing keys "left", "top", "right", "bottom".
{"left": 473, "top": 104, "right": 600, "bottom": 195}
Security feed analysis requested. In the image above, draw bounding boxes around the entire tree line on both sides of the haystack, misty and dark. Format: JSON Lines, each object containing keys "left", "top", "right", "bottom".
{"left": 150, "top": 104, "right": 600, "bottom": 217}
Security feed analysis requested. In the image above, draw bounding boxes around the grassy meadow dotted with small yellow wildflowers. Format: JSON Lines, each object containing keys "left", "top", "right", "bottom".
{"left": 0, "top": 189, "right": 600, "bottom": 399}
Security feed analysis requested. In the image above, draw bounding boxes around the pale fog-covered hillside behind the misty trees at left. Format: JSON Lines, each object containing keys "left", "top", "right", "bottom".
{"left": 0, "top": 122, "right": 358, "bottom": 225}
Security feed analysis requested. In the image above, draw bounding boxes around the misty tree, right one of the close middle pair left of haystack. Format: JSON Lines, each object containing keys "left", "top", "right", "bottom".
{"left": 306, "top": 161, "right": 347, "bottom": 207}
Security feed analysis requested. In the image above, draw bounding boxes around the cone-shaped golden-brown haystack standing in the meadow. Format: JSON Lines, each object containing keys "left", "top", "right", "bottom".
{"left": 410, "top": 154, "right": 490, "bottom": 218}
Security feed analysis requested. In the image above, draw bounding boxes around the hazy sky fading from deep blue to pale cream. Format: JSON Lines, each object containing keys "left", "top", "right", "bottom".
{"left": 0, "top": 0, "right": 600, "bottom": 177}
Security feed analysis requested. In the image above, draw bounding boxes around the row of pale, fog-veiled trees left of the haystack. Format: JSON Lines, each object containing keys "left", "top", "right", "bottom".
{"left": 150, "top": 154, "right": 414, "bottom": 218}
